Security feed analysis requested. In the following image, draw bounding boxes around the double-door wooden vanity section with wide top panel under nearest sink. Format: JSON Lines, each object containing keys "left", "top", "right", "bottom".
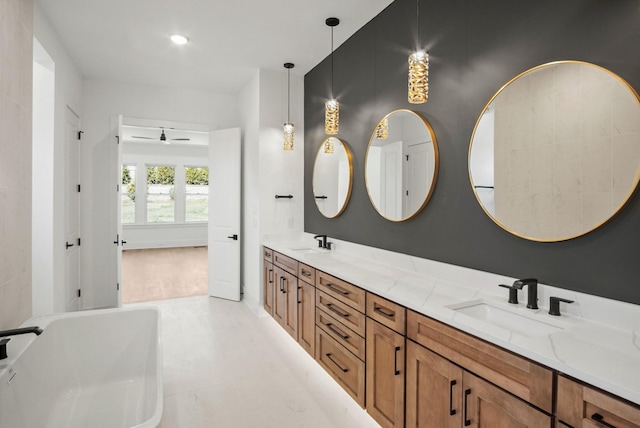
{"left": 406, "top": 311, "right": 553, "bottom": 428}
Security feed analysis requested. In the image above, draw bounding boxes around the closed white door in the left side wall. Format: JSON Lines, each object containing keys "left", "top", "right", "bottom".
{"left": 64, "top": 109, "right": 81, "bottom": 311}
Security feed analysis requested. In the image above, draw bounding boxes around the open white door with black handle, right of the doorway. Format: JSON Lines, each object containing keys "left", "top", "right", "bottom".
{"left": 209, "top": 128, "right": 242, "bottom": 301}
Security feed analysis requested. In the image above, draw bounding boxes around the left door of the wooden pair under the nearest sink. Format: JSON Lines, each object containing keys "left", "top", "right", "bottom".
{"left": 406, "top": 340, "right": 462, "bottom": 428}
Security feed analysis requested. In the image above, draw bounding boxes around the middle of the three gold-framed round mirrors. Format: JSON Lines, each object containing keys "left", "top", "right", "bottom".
{"left": 365, "top": 110, "right": 438, "bottom": 221}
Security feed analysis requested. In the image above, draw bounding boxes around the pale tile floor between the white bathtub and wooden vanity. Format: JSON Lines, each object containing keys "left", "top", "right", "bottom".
{"left": 127, "top": 296, "right": 379, "bottom": 428}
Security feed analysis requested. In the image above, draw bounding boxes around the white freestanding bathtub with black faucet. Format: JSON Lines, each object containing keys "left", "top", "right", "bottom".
{"left": 0, "top": 307, "right": 162, "bottom": 428}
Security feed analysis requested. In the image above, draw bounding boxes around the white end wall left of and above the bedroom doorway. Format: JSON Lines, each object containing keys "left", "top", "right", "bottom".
{"left": 82, "top": 79, "right": 239, "bottom": 308}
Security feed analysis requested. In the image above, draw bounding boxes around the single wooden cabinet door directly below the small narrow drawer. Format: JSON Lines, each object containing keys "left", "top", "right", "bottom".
{"left": 365, "top": 318, "right": 405, "bottom": 428}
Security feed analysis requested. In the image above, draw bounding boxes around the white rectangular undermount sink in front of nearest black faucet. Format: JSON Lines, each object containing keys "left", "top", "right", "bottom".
{"left": 449, "top": 299, "right": 564, "bottom": 337}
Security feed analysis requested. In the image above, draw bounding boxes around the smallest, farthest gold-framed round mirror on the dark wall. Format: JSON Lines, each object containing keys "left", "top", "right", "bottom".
{"left": 313, "top": 137, "right": 353, "bottom": 218}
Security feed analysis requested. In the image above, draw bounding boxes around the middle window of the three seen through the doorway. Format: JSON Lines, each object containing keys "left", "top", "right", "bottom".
{"left": 147, "top": 166, "right": 176, "bottom": 223}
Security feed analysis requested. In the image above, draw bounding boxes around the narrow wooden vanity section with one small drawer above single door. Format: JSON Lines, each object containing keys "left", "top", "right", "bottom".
{"left": 366, "top": 293, "right": 406, "bottom": 428}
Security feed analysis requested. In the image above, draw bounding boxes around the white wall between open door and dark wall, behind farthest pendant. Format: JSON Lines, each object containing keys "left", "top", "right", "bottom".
{"left": 239, "top": 68, "right": 304, "bottom": 311}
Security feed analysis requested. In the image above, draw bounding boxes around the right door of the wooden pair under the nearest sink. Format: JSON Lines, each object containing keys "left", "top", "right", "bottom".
{"left": 462, "top": 371, "right": 551, "bottom": 428}
